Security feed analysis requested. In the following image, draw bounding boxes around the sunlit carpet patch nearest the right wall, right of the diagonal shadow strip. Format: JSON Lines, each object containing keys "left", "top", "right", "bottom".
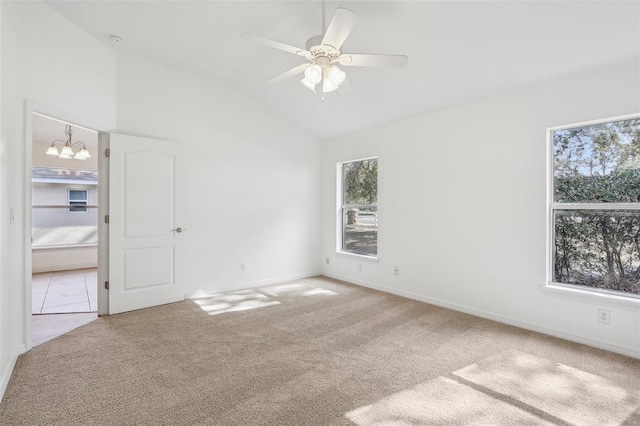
{"left": 453, "top": 350, "right": 640, "bottom": 426}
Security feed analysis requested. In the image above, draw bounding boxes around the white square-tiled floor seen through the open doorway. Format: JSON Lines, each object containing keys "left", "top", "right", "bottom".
{"left": 31, "top": 268, "right": 98, "bottom": 314}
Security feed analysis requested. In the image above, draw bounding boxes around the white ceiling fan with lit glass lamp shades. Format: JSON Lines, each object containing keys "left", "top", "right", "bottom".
{"left": 243, "top": 2, "right": 408, "bottom": 93}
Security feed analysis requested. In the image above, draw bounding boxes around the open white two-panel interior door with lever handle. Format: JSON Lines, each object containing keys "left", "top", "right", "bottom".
{"left": 108, "top": 133, "right": 185, "bottom": 314}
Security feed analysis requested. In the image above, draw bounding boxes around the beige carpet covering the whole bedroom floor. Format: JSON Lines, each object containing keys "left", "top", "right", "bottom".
{"left": 0, "top": 278, "right": 640, "bottom": 426}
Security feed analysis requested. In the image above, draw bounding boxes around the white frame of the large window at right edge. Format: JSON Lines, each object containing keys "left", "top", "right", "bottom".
{"left": 544, "top": 113, "right": 640, "bottom": 305}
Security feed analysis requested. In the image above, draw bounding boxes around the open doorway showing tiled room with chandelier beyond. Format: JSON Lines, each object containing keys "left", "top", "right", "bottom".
{"left": 31, "top": 113, "right": 99, "bottom": 345}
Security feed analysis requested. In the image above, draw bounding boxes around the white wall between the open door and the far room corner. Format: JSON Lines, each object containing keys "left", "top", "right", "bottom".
{"left": 117, "top": 57, "right": 320, "bottom": 297}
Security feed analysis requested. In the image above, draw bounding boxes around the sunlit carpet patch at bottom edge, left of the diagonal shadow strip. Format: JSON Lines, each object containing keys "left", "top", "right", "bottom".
{"left": 346, "top": 377, "right": 552, "bottom": 426}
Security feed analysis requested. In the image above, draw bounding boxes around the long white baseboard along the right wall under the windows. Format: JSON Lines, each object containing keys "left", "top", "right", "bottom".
{"left": 322, "top": 272, "right": 640, "bottom": 359}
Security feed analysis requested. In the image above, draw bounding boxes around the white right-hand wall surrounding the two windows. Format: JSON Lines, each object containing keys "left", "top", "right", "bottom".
{"left": 322, "top": 60, "right": 640, "bottom": 357}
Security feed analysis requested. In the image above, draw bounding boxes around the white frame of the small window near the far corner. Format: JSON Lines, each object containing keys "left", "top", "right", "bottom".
{"left": 336, "top": 156, "right": 379, "bottom": 262}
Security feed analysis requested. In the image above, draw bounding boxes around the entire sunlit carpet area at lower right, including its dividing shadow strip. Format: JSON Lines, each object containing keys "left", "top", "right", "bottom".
{"left": 346, "top": 350, "right": 640, "bottom": 426}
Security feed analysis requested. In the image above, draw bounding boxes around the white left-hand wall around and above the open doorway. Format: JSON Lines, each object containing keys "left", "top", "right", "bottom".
{"left": 0, "top": 2, "right": 116, "bottom": 394}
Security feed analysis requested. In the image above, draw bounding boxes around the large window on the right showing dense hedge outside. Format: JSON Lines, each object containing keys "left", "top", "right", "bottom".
{"left": 549, "top": 117, "right": 640, "bottom": 297}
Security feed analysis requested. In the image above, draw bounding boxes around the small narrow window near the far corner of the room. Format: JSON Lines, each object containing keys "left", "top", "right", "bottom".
{"left": 338, "top": 158, "right": 378, "bottom": 257}
